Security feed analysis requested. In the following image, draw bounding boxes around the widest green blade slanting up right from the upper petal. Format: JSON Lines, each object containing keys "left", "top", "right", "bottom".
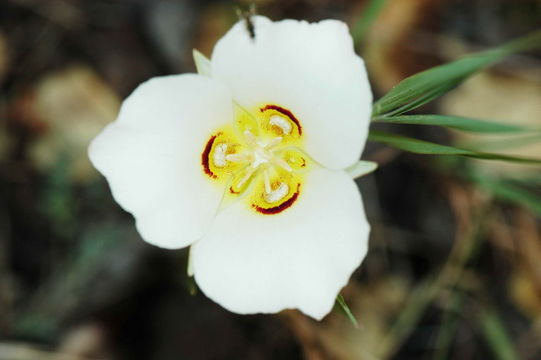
{"left": 373, "top": 31, "right": 541, "bottom": 116}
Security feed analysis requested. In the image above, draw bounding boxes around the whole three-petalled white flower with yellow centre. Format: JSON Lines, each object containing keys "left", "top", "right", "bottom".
{"left": 89, "top": 17, "right": 372, "bottom": 319}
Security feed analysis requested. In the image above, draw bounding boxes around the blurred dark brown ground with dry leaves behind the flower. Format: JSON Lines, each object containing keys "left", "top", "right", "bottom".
{"left": 0, "top": 0, "right": 541, "bottom": 360}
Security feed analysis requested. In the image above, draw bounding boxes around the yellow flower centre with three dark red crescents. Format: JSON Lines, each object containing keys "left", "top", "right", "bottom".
{"left": 201, "top": 105, "right": 307, "bottom": 215}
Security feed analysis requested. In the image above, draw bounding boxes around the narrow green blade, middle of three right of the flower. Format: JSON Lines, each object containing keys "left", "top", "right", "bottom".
{"left": 374, "top": 115, "right": 529, "bottom": 133}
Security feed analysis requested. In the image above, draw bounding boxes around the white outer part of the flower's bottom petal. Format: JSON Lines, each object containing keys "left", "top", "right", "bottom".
{"left": 192, "top": 169, "right": 370, "bottom": 319}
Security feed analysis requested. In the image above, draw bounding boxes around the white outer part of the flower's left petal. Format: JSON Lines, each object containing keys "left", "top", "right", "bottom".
{"left": 89, "top": 75, "right": 233, "bottom": 248}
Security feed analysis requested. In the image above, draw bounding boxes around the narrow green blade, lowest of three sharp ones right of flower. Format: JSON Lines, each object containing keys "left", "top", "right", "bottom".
{"left": 368, "top": 130, "right": 541, "bottom": 165}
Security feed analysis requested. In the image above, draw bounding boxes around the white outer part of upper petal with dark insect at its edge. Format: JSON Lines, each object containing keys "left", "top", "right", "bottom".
{"left": 211, "top": 17, "right": 372, "bottom": 169}
